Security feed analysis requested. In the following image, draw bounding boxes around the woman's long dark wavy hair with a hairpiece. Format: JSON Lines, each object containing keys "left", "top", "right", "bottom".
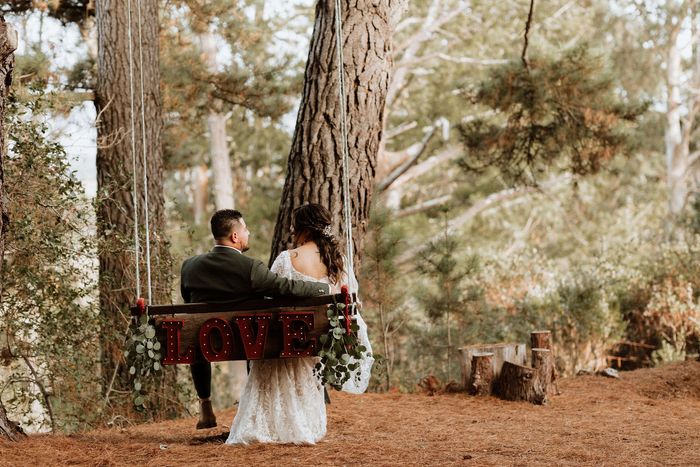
{"left": 292, "top": 203, "right": 344, "bottom": 283}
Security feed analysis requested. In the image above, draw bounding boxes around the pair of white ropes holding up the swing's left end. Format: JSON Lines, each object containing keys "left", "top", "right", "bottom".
{"left": 127, "top": 0, "right": 152, "bottom": 305}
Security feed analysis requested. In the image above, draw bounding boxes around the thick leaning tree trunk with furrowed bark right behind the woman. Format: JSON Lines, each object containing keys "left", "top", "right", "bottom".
{"left": 270, "top": 0, "right": 404, "bottom": 268}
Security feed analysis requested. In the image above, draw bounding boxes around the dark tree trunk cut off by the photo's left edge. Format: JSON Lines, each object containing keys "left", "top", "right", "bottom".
{"left": 0, "top": 15, "right": 24, "bottom": 441}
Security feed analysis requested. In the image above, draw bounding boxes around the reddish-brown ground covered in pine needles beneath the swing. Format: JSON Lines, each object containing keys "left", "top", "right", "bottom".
{"left": 0, "top": 362, "right": 700, "bottom": 466}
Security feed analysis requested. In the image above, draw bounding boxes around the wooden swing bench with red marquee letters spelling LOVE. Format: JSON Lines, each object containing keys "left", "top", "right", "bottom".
{"left": 131, "top": 293, "right": 354, "bottom": 365}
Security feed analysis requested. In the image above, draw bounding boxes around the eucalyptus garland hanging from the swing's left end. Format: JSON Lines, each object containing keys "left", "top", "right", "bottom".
{"left": 124, "top": 314, "right": 162, "bottom": 410}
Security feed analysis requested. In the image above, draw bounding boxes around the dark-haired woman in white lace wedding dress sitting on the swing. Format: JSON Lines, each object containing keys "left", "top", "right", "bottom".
{"left": 226, "top": 204, "right": 374, "bottom": 444}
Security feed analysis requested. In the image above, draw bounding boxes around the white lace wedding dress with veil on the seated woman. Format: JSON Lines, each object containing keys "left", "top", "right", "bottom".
{"left": 226, "top": 251, "right": 374, "bottom": 444}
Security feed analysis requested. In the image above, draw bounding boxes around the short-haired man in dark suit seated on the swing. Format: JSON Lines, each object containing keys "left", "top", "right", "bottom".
{"left": 180, "top": 209, "right": 330, "bottom": 429}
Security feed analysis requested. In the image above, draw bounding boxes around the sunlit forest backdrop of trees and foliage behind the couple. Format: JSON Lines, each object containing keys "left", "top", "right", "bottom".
{"left": 0, "top": 0, "right": 700, "bottom": 431}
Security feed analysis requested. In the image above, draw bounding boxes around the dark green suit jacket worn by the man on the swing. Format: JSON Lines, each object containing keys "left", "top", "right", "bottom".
{"left": 180, "top": 245, "right": 330, "bottom": 303}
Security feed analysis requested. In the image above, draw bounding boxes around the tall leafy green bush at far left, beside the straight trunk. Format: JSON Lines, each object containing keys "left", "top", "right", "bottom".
{"left": 0, "top": 89, "right": 100, "bottom": 430}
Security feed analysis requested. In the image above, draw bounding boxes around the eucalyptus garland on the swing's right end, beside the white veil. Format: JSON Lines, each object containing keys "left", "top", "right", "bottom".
{"left": 314, "top": 303, "right": 367, "bottom": 390}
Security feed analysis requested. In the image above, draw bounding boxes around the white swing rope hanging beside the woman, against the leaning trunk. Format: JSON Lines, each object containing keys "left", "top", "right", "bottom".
{"left": 335, "top": 0, "right": 355, "bottom": 292}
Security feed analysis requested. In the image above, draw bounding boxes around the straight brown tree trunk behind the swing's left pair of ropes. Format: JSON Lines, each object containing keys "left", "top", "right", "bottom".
{"left": 95, "top": 0, "right": 175, "bottom": 414}
